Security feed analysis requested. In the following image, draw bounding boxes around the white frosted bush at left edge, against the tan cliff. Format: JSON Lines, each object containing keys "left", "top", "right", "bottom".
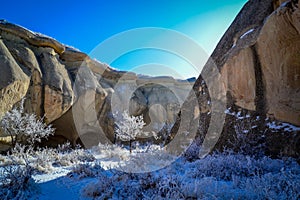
{"left": 0, "top": 99, "right": 54, "bottom": 146}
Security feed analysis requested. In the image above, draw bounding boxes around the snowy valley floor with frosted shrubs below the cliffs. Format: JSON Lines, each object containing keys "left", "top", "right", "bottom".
{"left": 0, "top": 105, "right": 300, "bottom": 200}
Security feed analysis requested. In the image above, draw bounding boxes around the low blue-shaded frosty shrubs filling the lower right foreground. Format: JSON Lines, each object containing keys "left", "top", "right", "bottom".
{"left": 82, "top": 153, "right": 300, "bottom": 200}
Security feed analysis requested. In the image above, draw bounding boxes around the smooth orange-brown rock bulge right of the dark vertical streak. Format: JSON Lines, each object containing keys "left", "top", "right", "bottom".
{"left": 255, "top": 1, "right": 300, "bottom": 126}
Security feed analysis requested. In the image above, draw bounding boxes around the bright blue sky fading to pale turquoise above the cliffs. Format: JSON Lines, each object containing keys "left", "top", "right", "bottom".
{"left": 0, "top": 0, "right": 247, "bottom": 78}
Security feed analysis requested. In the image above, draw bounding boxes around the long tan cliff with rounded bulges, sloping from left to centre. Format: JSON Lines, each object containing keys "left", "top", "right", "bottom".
{"left": 0, "top": 21, "right": 193, "bottom": 146}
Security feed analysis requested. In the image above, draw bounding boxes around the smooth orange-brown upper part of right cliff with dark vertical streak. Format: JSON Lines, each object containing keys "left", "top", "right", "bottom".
{"left": 217, "top": 1, "right": 300, "bottom": 126}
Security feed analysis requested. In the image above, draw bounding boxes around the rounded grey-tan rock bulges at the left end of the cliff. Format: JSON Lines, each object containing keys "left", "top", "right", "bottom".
{"left": 0, "top": 27, "right": 74, "bottom": 123}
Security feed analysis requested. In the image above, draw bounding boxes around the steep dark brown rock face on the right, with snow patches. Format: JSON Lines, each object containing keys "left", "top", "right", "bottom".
{"left": 172, "top": 0, "right": 300, "bottom": 157}
